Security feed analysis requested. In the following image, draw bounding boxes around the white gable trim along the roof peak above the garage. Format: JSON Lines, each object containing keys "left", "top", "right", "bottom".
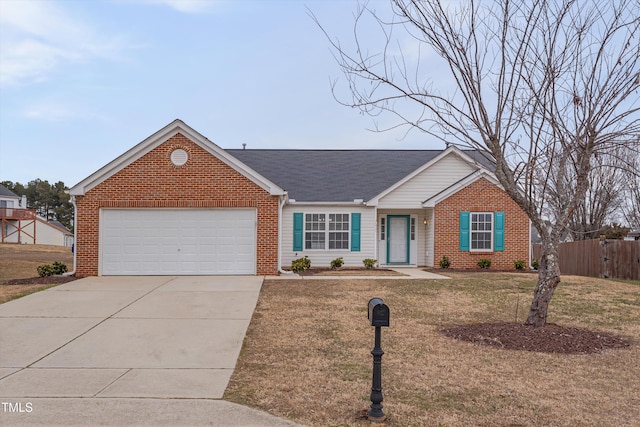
{"left": 69, "top": 119, "right": 285, "bottom": 196}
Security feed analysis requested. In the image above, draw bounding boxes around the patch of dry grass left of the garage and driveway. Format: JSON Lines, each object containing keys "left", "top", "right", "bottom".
{"left": 0, "top": 243, "right": 73, "bottom": 304}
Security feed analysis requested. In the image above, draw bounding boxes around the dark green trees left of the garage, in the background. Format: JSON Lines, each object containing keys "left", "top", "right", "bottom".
{"left": 1, "top": 178, "right": 73, "bottom": 231}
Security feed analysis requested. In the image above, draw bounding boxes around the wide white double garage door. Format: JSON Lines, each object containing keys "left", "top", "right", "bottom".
{"left": 100, "top": 209, "right": 256, "bottom": 275}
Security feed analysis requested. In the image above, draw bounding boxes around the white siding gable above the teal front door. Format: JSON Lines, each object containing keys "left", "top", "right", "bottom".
{"left": 378, "top": 154, "right": 475, "bottom": 209}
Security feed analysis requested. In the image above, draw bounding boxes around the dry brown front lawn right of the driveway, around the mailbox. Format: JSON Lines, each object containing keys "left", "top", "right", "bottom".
{"left": 225, "top": 273, "right": 640, "bottom": 426}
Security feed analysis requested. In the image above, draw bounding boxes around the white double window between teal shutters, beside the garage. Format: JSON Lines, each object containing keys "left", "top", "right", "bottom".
{"left": 304, "top": 213, "right": 349, "bottom": 250}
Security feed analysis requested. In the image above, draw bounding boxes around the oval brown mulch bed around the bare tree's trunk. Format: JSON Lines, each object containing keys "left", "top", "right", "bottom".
{"left": 442, "top": 322, "right": 631, "bottom": 354}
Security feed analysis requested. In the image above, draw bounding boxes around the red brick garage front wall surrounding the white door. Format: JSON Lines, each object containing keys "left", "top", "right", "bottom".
{"left": 76, "top": 134, "right": 278, "bottom": 276}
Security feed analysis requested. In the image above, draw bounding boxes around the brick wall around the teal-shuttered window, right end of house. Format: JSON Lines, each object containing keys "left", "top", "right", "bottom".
{"left": 434, "top": 178, "right": 529, "bottom": 270}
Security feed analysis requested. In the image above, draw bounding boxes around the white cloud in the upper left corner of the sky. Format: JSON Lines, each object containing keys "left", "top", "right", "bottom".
{"left": 0, "top": 0, "right": 129, "bottom": 86}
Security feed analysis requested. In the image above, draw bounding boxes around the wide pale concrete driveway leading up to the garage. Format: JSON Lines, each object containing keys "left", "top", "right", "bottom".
{"left": 0, "top": 276, "right": 302, "bottom": 426}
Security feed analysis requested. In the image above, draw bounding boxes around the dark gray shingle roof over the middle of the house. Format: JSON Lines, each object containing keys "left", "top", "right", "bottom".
{"left": 226, "top": 149, "right": 486, "bottom": 202}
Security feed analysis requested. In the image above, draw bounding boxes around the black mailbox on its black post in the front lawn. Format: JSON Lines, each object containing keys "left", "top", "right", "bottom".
{"left": 367, "top": 298, "right": 389, "bottom": 421}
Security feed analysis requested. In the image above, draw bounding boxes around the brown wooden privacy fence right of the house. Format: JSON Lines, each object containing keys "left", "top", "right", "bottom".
{"left": 532, "top": 239, "right": 640, "bottom": 280}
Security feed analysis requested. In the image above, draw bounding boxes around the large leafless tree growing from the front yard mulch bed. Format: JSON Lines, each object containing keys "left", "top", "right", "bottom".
{"left": 316, "top": 0, "right": 640, "bottom": 326}
